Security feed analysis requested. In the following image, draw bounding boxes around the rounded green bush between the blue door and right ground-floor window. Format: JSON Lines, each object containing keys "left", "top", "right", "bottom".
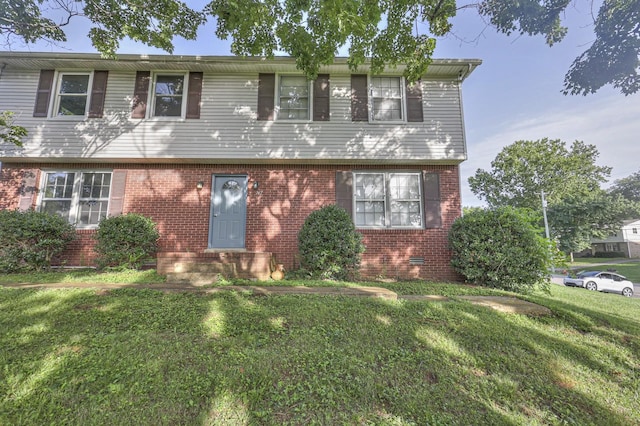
{"left": 298, "top": 205, "right": 364, "bottom": 280}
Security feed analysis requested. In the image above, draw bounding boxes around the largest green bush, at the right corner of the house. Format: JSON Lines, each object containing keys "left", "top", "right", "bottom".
{"left": 449, "top": 207, "right": 557, "bottom": 293}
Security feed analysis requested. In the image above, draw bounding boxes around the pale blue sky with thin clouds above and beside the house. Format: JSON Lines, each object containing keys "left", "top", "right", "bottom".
{"left": 11, "top": 0, "right": 640, "bottom": 206}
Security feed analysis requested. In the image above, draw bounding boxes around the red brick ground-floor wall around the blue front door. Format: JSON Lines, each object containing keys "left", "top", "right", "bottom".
{"left": 0, "top": 164, "right": 461, "bottom": 280}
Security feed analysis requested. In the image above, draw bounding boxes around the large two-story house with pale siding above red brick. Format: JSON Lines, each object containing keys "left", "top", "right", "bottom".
{"left": 0, "top": 52, "right": 480, "bottom": 280}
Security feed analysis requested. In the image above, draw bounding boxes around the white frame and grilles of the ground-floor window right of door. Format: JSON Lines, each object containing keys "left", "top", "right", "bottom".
{"left": 351, "top": 170, "right": 426, "bottom": 229}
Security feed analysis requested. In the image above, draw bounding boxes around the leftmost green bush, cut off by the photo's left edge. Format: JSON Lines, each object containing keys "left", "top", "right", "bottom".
{"left": 0, "top": 210, "right": 75, "bottom": 272}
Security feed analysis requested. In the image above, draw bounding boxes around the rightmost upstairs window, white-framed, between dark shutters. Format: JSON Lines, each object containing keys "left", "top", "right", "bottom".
{"left": 371, "top": 77, "right": 404, "bottom": 121}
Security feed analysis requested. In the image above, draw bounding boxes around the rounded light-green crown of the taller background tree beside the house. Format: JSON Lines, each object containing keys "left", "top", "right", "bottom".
{"left": 469, "top": 138, "right": 611, "bottom": 210}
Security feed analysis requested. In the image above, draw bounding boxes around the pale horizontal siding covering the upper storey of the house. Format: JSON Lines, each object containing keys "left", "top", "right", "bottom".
{"left": 0, "top": 67, "right": 466, "bottom": 165}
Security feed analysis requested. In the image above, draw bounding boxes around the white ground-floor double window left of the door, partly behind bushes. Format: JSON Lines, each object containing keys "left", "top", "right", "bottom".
{"left": 40, "top": 172, "right": 111, "bottom": 228}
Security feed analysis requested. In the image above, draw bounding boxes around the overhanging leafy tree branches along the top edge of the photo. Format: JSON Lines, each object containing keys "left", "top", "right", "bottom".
{"left": 0, "top": 0, "right": 640, "bottom": 95}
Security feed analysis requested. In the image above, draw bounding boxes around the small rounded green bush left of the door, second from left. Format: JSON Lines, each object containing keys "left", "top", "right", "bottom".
{"left": 95, "top": 213, "right": 160, "bottom": 269}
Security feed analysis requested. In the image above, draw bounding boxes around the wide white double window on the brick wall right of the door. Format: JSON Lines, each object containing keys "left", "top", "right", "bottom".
{"left": 353, "top": 172, "right": 423, "bottom": 228}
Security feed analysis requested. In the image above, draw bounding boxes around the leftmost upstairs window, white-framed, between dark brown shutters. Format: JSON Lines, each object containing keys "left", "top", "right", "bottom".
{"left": 52, "top": 72, "right": 91, "bottom": 117}
